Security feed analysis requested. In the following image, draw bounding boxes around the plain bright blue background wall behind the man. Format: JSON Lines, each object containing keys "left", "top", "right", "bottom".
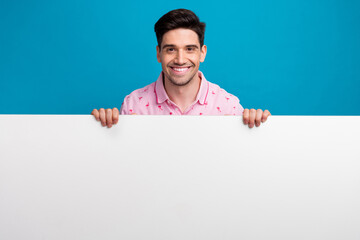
{"left": 0, "top": 0, "right": 360, "bottom": 115}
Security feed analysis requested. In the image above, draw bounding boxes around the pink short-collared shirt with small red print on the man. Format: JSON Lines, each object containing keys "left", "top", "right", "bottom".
{"left": 120, "top": 71, "right": 244, "bottom": 115}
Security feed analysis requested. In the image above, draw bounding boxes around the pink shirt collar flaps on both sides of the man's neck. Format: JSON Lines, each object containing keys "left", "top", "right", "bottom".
{"left": 154, "top": 71, "right": 209, "bottom": 104}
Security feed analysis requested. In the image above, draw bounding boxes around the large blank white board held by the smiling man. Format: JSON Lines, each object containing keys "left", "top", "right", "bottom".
{"left": 0, "top": 115, "right": 360, "bottom": 240}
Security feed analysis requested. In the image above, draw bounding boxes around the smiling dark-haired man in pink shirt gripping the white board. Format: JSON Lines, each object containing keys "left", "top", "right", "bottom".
{"left": 92, "top": 9, "right": 271, "bottom": 128}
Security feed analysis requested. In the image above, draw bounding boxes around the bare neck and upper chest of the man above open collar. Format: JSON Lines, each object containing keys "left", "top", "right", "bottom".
{"left": 163, "top": 71, "right": 201, "bottom": 112}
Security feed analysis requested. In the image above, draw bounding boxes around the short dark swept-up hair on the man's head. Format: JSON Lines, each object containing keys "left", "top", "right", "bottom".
{"left": 154, "top": 9, "right": 205, "bottom": 50}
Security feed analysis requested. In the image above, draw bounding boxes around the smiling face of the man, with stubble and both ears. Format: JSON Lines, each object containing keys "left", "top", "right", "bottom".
{"left": 156, "top": 28, "right": 206, "bottom": 86}
